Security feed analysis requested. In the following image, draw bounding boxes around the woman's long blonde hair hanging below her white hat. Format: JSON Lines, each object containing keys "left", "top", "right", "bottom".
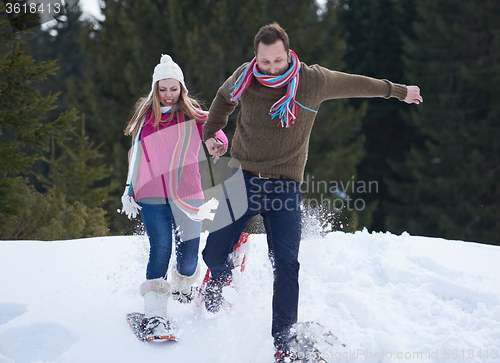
{"left": 125, "top": 81, "right": 206, "bottom": 136}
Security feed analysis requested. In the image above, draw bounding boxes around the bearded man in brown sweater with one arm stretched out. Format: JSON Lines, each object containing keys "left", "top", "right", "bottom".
{"left": 203, "top": 23, "right": 423, "bottom": 361}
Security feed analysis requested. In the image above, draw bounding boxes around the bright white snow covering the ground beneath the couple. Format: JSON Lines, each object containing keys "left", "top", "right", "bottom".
{"left": 0, "top": 226, "right": 500, "bottom": 363}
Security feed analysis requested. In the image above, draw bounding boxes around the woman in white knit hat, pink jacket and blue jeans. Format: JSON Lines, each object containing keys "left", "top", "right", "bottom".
{"left": 122, "top": 55, "right": 228, "bottom": 336}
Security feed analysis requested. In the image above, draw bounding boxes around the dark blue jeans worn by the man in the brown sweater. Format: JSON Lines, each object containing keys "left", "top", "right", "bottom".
{"left": 202, "top": 172, "right": 302, "bottom": 343}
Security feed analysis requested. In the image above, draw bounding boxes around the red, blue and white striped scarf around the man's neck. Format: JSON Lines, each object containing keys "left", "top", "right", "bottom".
{"left": 231, "top": 50, "right": 310, "bottom": 128}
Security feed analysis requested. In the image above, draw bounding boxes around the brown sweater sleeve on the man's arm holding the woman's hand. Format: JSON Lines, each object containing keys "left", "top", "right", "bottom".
{"left": 203, "top": 63, "right": 248, "bottom": 141}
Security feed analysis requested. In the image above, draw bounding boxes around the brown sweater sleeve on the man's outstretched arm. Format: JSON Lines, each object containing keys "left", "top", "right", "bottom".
{"left": 311, "top": 65, "right": 407, "bottom": 101}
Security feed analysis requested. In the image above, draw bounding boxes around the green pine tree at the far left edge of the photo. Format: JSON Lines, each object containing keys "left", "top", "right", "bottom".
{"left": 0, "top": 4, "right": 76, "bottom": 225}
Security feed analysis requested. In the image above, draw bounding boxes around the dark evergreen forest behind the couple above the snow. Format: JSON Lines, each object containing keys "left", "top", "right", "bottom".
{"left": 0, "top": 0, "right": 500, "bottom": 245}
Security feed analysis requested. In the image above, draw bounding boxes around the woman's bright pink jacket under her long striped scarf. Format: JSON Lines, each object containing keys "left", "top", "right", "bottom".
{"left": 134, "top": 110, "right": 228, "bottom": 200}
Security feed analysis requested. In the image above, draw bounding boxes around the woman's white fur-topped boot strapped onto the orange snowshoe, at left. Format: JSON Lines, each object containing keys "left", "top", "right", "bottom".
{"left": 141, "top": 278, "right": 172, "bottom": 336}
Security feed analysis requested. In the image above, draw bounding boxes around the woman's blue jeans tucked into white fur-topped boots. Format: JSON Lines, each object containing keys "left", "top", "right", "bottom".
{"left": 139, "top": 198, "right": 203, "bottom": 280}
